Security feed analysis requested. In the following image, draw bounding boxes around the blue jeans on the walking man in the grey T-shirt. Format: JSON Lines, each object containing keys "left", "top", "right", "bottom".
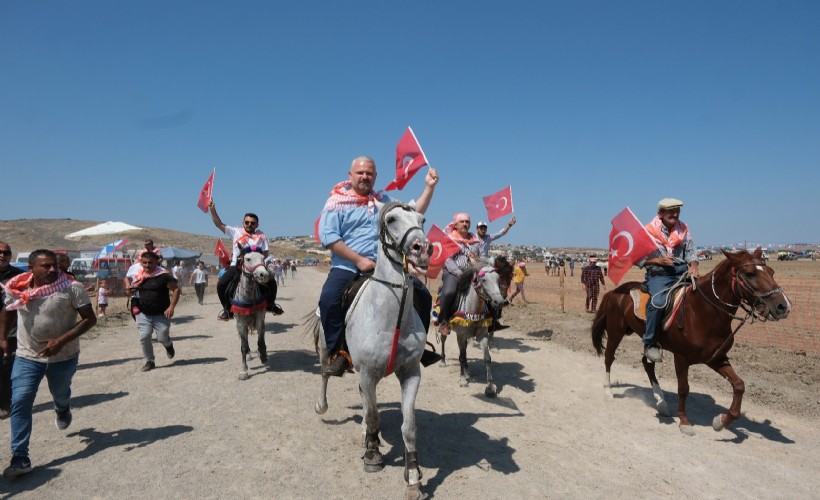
{"left": 11, "top": 356, "right": 79, "bottom": 457}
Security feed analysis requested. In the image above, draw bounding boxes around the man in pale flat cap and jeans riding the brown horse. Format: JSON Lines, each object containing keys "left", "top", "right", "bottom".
{"left": 636, "top": 198, "right": 699, "bottom": 363}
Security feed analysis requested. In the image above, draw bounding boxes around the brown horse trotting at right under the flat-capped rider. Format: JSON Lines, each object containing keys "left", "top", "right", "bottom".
{"left": 592, "top": 248, "right": 791, "bottom": 434}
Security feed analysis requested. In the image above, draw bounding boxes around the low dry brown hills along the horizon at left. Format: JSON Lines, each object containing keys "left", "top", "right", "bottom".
{"left": 0, "top": 219, "right": 316, "bottom": 259}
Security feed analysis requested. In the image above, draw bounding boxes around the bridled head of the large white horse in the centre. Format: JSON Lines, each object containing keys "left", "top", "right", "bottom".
{"left": 376, "top": 202, "right": 433, "bottom": 274}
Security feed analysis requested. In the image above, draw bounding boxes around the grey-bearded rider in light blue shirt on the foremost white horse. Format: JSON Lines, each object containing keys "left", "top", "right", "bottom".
{"left": 318, "top": 156, "right": 438, "bottom": 377}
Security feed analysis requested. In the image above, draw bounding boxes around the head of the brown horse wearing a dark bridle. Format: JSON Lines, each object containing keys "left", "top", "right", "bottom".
{"left": 723, "top": 247, "right": 792, "bottom": 321}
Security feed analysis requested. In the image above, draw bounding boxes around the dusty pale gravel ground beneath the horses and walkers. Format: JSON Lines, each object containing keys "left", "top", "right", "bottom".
{"left": 0, "top": 268, "right": 820, "bottom": 499}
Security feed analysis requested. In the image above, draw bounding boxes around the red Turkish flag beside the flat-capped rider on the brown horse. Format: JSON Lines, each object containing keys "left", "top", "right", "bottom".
{"left": 608, "top": 207, "right": 658, "bottom": 285}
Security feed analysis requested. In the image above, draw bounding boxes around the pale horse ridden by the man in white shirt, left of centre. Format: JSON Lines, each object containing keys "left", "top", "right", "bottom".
{"left": 231, "top": 246, "right": 272, "bottom": 380}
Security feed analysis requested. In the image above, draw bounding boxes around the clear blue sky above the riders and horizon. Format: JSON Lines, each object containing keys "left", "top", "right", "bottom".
{"left": 0, "top": 0, "right": 820, "bottom": 247}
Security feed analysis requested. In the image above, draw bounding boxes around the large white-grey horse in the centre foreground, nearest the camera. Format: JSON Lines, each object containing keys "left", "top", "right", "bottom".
{"left": 312, "top": 202, "right": 432, "bottom": 498}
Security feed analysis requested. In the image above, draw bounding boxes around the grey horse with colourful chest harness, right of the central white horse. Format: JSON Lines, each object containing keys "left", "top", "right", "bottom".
{"left": 441, "top": 265, "right": 504, "bottom": 398}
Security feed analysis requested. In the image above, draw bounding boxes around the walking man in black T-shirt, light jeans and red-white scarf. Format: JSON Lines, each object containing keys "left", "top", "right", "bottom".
{"left": 128, "top": 252, "right": 179, "bottom": 372}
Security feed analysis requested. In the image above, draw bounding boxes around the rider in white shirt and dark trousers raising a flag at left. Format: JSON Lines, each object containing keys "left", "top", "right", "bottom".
{"left": 208, "top": 199, "right": 282, "bottom": 321}
